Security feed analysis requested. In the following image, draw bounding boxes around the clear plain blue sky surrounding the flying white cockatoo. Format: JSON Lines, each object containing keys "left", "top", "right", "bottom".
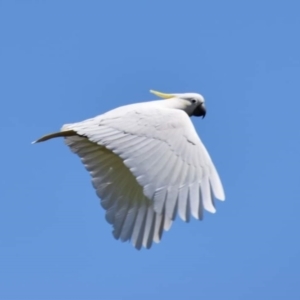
{"left": 0, "top": 0, "right": 300, "bottom": 300}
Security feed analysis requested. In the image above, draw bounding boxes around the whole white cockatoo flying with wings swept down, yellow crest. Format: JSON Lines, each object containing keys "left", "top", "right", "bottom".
{"left": 33, "top": 90, "right": 225, "bottom": 249}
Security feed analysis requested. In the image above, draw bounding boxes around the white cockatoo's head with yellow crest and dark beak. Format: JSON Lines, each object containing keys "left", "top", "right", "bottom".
{"left": 150, "top": 90, "right": 206, "bottom": 118}
